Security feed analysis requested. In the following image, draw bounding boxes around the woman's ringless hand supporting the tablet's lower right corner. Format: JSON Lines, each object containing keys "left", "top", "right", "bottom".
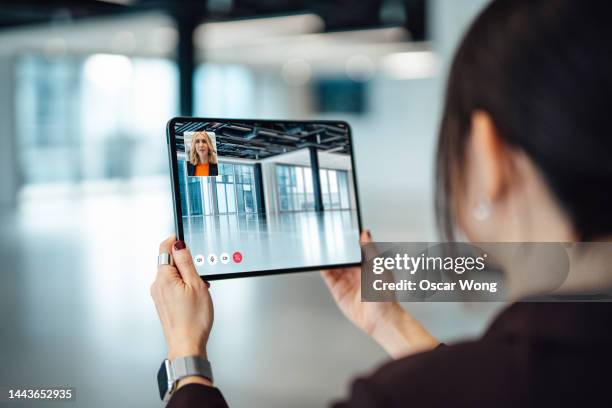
{"left": 321, "top": 231, "right": 440, "bottom": 358}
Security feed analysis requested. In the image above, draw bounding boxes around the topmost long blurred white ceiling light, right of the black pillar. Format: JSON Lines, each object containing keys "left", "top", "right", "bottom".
{"left": 194, "top": 14, "right": 325, "bottom": 48}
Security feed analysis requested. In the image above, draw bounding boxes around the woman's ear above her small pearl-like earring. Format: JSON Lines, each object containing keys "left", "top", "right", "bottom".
{"left": 470, "top": 110, "right": 509, "bottom": 202}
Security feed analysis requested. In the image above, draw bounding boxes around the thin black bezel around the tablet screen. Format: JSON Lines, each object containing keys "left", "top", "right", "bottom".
{"left": 166, "top": 116, "right": 363, "bottom": 280}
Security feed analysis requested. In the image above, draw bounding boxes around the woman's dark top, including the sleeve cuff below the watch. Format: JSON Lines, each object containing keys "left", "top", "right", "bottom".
{"left": 168, "top": 303, "right": 612, "bottom": 408}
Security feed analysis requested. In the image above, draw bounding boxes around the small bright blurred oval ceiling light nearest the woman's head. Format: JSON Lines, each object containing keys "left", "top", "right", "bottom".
{"left": 381, "top": 51, "right": 438, "bottom": 79}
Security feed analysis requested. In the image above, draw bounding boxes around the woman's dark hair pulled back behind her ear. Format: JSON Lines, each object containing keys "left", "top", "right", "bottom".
{"left": 436, "top": 0, "right": 612, "bottom": 240}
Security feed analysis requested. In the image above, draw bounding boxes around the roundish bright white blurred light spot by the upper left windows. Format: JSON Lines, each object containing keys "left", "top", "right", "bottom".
{"left": 83, "top": 54, "right": 132, "bottom": 90}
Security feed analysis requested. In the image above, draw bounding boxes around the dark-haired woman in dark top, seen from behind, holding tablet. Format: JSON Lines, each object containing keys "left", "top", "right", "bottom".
{"left": 151, "top": 0, "right": 612, "bottom": 408}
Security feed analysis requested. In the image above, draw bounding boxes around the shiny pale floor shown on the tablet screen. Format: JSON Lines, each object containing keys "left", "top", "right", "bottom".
{"left": 183, "top": 210, "right": 361, "bottom": 275}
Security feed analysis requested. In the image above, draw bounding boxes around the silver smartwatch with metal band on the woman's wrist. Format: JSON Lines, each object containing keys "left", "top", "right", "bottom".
{"left": 157, "top": 356, "right": 213, "bottom": 402}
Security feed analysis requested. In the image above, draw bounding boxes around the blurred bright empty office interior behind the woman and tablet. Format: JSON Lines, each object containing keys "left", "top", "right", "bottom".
{"left": 0, "top": 0, "right": 500, "bottom": 407}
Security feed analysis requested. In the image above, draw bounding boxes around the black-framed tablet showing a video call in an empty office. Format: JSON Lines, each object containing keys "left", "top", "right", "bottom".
{"left": 167, "top": 117, "right": 361, "bottom": 280}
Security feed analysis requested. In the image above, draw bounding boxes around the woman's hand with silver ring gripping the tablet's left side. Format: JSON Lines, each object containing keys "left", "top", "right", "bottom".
{"left": 151, "top": 236, "right": 213, "bottom": 360}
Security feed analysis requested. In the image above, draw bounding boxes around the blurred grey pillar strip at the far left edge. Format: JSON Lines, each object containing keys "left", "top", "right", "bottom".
{"left": 0, "top": 56, "right": 20, "bottom": 207}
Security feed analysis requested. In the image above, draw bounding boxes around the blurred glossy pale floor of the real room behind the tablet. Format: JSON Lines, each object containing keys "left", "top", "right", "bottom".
{"left": 0, "top": 180, "right": 498, "bottom": 408}
